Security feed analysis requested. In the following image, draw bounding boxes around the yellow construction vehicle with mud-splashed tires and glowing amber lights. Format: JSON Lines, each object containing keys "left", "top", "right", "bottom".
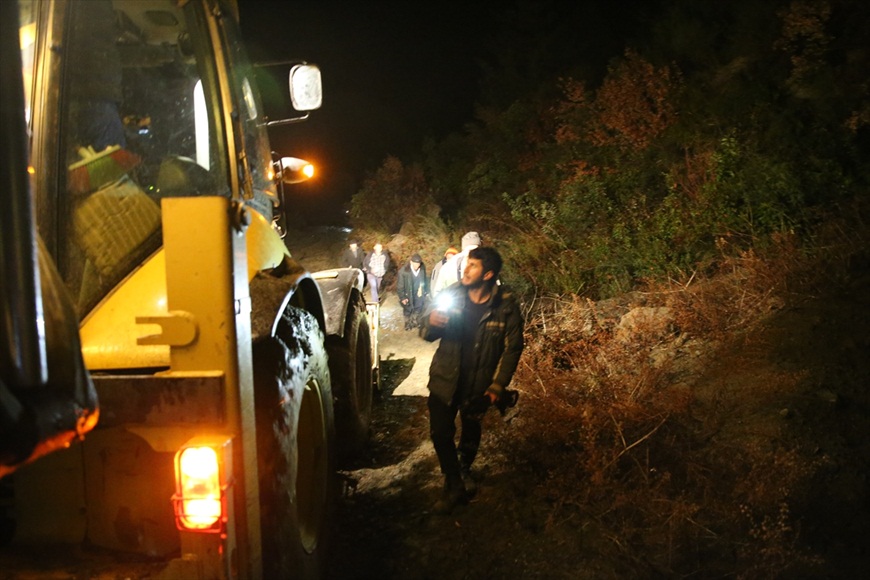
{"left": 0, "top": 0, "right": 378, "bottom": 578}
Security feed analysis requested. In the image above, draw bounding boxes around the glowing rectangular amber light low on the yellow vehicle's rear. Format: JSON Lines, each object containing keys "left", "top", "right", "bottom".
{"left": 172, "top": 447, "right": 224, "bottom": 532}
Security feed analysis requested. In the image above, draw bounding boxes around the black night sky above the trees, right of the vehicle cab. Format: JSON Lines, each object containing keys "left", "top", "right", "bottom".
{"left": 239, "top": 0, "right": 503, "bottom": 221}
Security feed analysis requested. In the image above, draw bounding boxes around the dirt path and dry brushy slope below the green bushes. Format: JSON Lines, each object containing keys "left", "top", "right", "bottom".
{"left": 291, "top": 224, "right": 870, "bottom": 579}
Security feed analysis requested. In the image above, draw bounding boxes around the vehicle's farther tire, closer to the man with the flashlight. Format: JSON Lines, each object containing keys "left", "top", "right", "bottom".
{"left": 326, "top": 293, "right": 374, "bottom": 463}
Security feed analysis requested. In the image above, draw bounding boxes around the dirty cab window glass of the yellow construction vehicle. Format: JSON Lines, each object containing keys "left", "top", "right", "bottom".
{"left": 20, "top": 0, "right": 238, "bottom": 315}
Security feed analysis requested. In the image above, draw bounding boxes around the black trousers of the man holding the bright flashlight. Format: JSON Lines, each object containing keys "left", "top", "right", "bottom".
{"left": 429, "top": 395, "right": 481, "bottom": 481}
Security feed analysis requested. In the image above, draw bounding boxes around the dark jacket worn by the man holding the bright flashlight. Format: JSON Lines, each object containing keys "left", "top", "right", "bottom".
{"left": 422, "top": 282, "right": 523, "bottom": 405}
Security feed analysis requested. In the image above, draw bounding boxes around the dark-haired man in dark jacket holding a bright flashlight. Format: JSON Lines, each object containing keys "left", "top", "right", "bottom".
{"left": 422, "top": 247, "right": 523, "bottom": 513}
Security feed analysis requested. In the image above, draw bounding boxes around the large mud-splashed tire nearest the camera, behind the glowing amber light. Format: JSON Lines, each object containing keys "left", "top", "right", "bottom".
{"left": 253, "top": 307, "right": 338, "bottom": 578}
